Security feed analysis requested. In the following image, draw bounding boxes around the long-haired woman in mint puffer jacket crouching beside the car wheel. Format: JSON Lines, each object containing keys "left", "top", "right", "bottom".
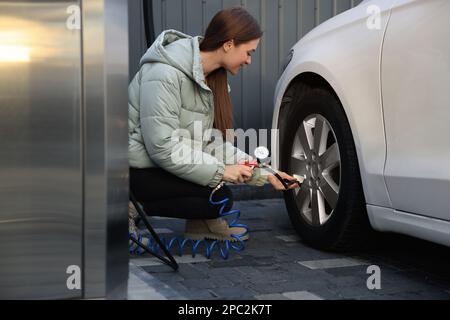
{"left": 129, "top": 7, "right": 294, "bottom": 240}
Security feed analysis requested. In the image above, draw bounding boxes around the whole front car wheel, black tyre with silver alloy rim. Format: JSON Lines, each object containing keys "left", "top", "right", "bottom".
{"left": 281, "top": 89, "right": 370, "bottom": 251}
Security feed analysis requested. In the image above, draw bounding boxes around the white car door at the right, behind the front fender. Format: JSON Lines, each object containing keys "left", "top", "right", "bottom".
{"left": 381, "top": 0, "right": 450, "bottom": 220}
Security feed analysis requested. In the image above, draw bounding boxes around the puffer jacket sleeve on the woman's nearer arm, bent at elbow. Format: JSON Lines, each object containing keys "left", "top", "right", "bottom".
{"left": 140, "top": 80, "right": 225, "bottom": 187}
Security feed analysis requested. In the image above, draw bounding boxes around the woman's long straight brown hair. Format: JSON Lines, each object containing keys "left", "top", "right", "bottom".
{"left": 200, "top": 7, "right": 263, "bottom": 137}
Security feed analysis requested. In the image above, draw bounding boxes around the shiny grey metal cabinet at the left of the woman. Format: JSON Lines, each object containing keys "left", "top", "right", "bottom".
{"left": 0, "top": 0, "right": 128, "bottom": 299}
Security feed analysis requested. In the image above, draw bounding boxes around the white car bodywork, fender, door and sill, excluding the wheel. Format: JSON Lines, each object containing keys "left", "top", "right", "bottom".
{"left": 272, "top": 0, "right": 450, "bottom": 246}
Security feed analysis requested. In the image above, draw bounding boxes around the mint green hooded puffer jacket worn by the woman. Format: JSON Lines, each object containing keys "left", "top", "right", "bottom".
{"left": 128, "top": 30, "right": 251, "bottom": 187}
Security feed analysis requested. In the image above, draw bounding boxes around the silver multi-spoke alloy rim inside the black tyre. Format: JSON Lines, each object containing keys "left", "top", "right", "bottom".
{"left": 289, "top": 114, "right": 341, "bottom": 226}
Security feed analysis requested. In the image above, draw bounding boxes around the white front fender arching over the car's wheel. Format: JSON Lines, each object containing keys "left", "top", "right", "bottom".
{"left": 272, "top": 1, "right": 393, "bottom": 207}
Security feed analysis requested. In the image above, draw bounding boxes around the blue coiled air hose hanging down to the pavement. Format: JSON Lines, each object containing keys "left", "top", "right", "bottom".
{"left": 129, "top": 183, "right": 249, "bottom": 259}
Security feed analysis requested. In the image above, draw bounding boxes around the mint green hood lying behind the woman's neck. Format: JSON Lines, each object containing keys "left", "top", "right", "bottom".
{"left": 140, "top": 29, "right": 207, "bottom": 89}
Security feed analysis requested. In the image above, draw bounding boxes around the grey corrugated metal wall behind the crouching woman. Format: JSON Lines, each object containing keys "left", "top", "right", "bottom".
{"left": 130, "top": 0, "right": 361, "bottom": 129}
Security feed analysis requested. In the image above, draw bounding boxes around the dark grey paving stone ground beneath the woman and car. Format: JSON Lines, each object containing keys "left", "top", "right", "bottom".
{"left": 128, "top": 199, "right": 450, "bottom": 300}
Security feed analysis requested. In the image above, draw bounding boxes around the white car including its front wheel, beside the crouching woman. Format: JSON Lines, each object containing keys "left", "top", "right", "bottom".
{"left": 272, "top": 0, "right": 450, "bottom": 251}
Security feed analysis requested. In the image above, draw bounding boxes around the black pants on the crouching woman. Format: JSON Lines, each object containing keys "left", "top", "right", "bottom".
{"left": 130, "top": 168, "right": 233, "bottom": 219}
